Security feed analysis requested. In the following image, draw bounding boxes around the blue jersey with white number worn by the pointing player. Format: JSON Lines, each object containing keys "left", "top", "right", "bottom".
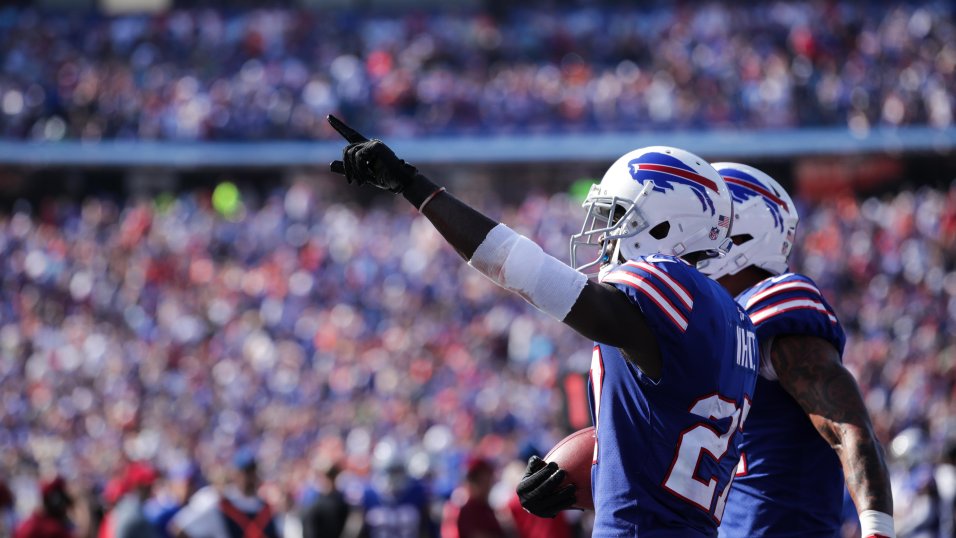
{"left": 589, "top": 255, "right": 760, "bottom": 537}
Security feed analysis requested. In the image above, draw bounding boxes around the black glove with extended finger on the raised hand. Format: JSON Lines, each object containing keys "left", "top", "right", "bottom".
{"left": 328, "top": 115, "right": 418, "bottom": 194}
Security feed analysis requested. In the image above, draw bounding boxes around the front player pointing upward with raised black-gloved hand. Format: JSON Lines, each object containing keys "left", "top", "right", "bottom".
{"left": 329, "top": 116, "right": 759, "bottom": 537}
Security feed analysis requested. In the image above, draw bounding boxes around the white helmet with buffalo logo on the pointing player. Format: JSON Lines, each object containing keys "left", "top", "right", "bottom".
{"left": 571, "top": 146, "right": 733, "bottom": 278}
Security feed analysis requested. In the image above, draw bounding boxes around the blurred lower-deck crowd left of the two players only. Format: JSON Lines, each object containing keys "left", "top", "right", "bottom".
{"left": 0, "top": 184, "right": 590, "bottom": 536}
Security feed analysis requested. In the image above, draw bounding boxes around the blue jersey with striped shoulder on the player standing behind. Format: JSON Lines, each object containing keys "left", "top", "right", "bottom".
{"left": 720, "top": 273, "right": 846, "bottom": 538}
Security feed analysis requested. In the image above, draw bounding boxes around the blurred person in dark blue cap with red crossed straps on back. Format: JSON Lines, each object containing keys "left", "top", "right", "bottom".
{"left": 176, "top": 449, "right": 279, "bottom": 538}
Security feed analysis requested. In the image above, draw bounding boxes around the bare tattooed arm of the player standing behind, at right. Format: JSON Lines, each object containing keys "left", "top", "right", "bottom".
{"left": 770, "top": 335, "right": 893, "bottom": 515}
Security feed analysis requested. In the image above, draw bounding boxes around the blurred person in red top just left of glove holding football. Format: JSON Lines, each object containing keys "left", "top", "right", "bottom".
{"left": 441, "top": 457, "right": 506, "bottom": 538}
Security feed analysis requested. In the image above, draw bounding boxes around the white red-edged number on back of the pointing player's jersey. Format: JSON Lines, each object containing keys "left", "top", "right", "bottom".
{"left": 663, "top": 394, "right": 750, "bottom": 524}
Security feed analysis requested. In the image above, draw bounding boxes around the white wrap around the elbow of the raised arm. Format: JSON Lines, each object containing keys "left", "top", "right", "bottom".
{"left": 468, "top": 224, "right": 588, "bottom": 320}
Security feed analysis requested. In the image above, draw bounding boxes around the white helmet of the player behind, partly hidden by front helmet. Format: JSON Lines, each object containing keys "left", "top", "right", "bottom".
{"left": 697, "top": 163, "right": 800, "bottom": 279}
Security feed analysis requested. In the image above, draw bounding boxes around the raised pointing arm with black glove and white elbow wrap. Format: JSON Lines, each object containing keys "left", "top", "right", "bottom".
{"left": 329, "top": 116, "right": 660, "bottom": 375}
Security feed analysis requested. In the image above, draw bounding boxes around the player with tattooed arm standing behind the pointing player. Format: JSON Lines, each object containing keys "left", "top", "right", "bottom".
{"left": 698, "top": 163, "right": 894, "bottom": 538}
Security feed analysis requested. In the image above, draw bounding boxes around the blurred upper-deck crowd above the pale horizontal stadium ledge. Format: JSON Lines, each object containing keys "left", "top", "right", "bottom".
{"left": 0, "top": 0, "right": 956, "bottom": 140}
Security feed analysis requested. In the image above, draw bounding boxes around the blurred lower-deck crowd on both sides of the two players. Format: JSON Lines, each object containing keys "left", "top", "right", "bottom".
{"left": 0, "top": 175, "right": 956, "bottom": 536}
